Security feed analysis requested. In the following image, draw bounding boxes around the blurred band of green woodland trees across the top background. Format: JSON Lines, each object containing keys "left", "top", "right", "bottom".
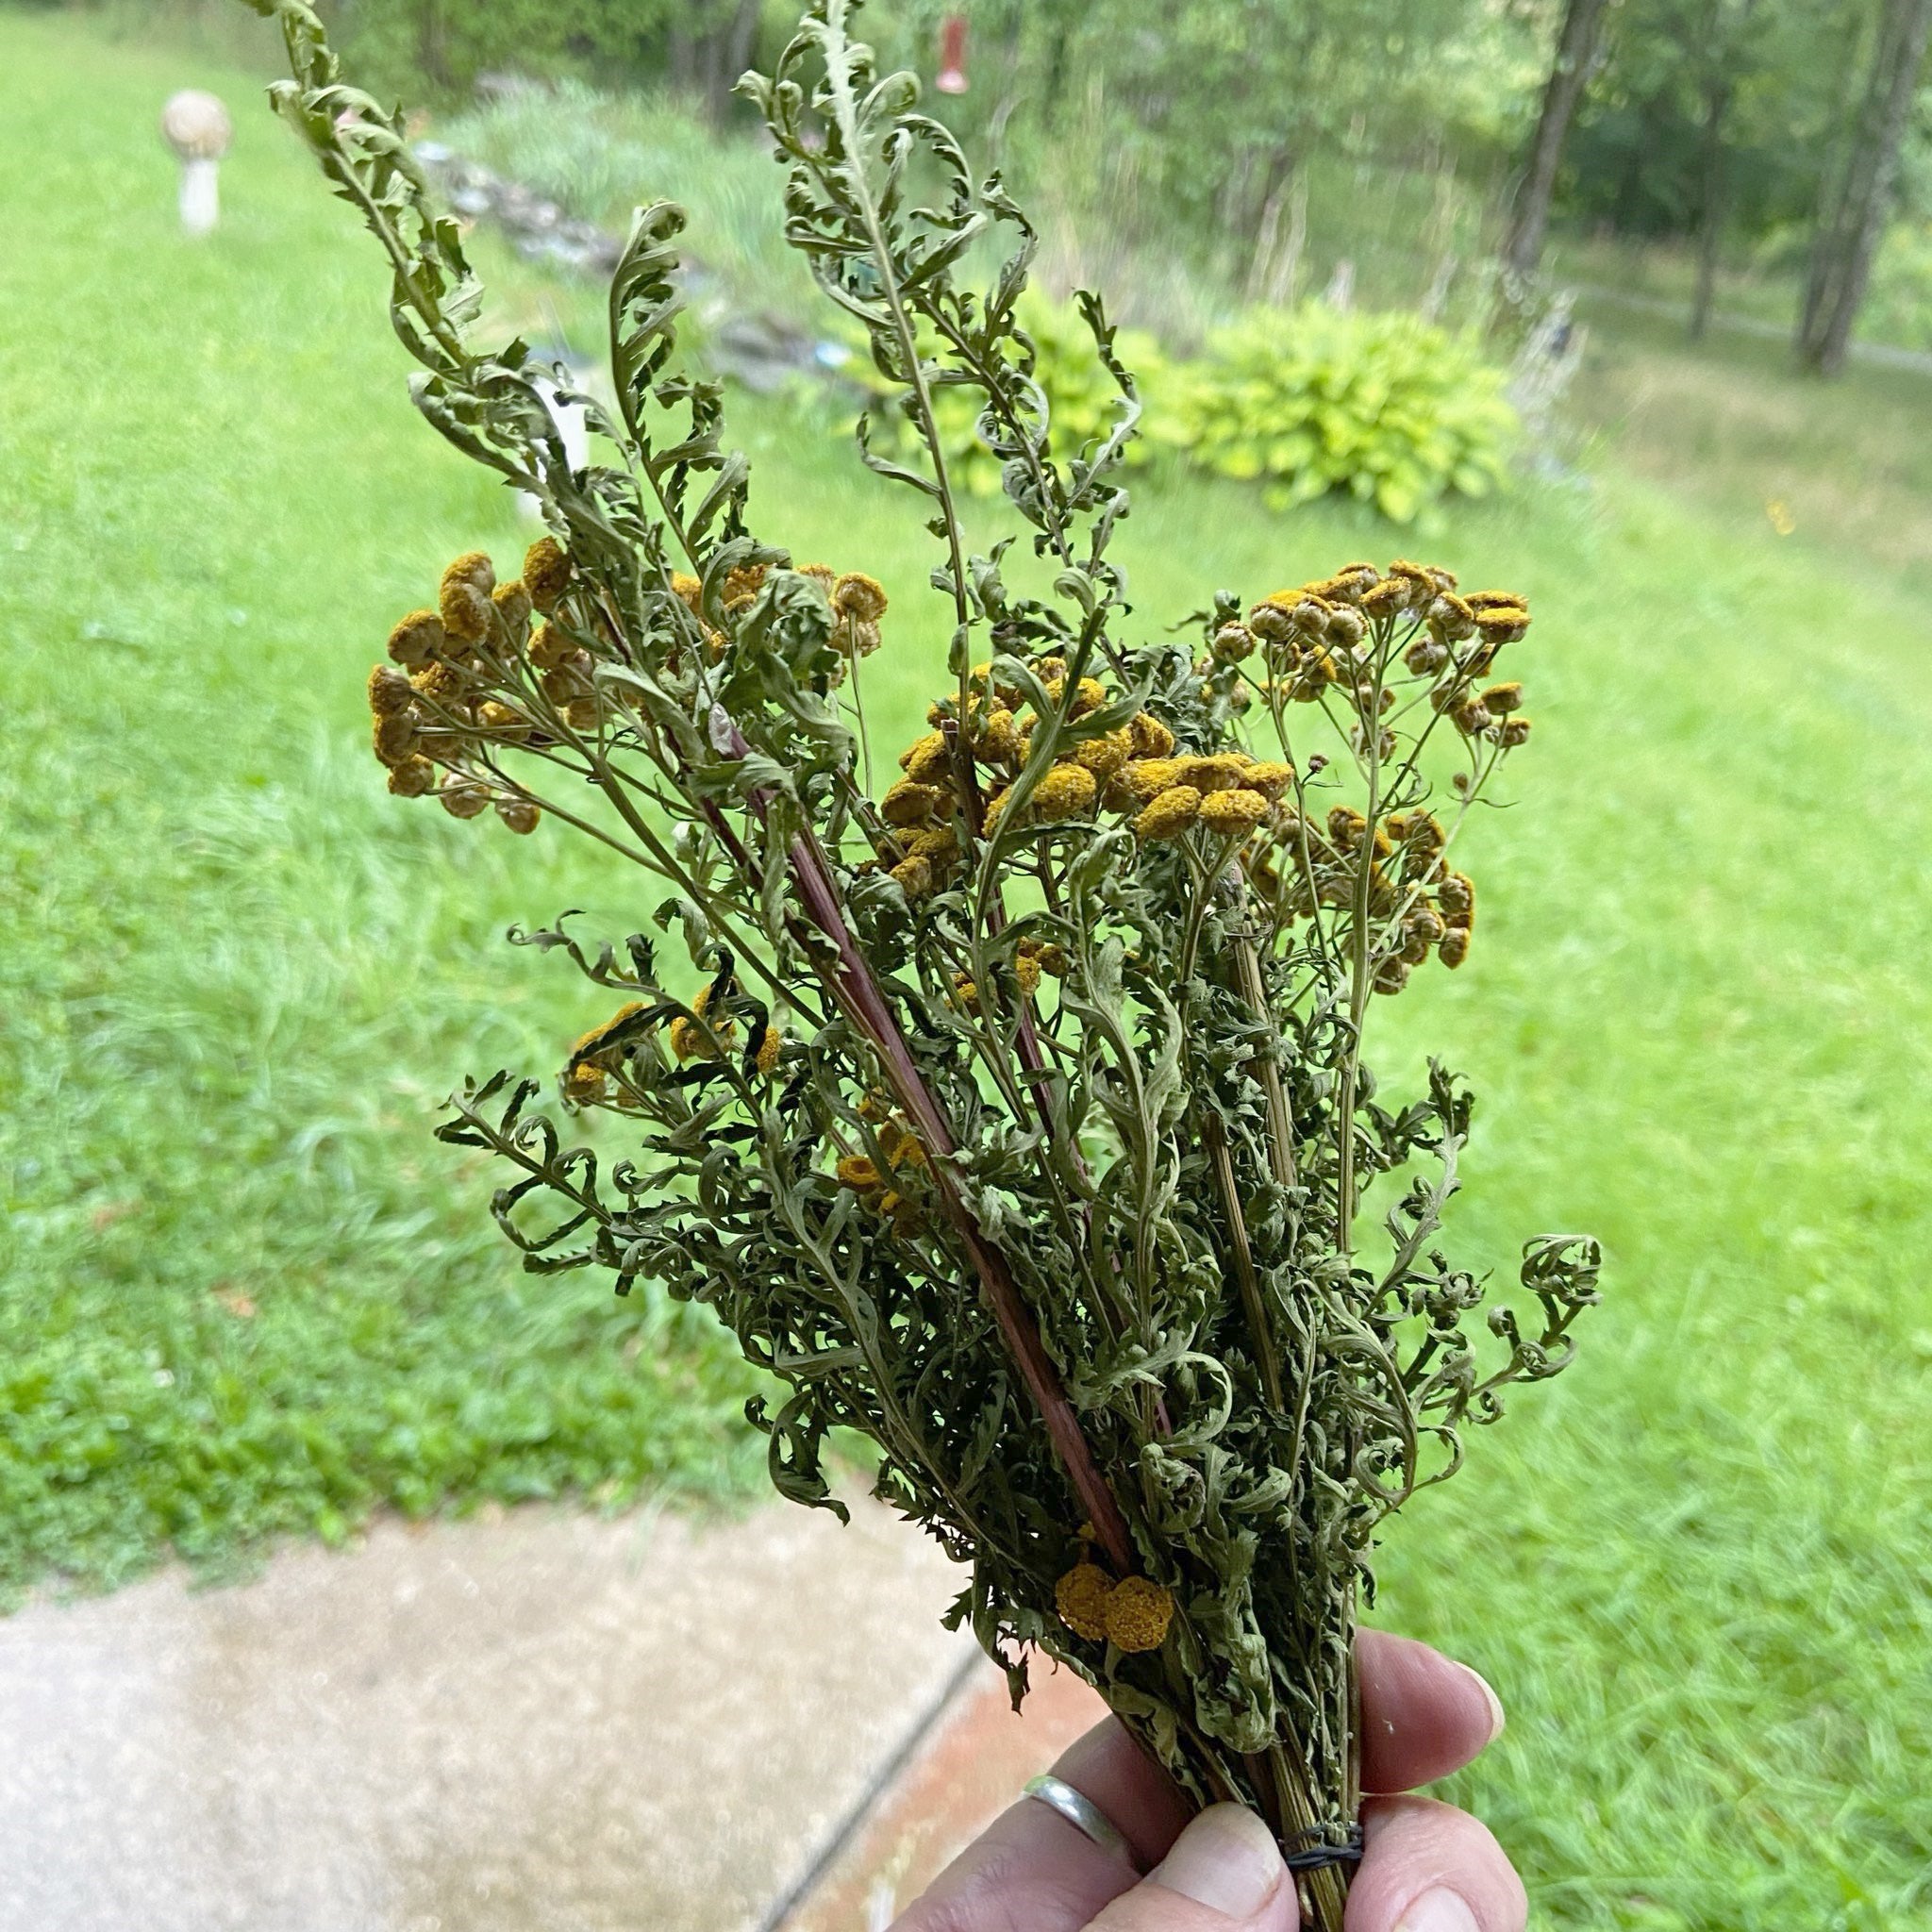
{"left": 297, "top": 0, "right": 1932, "bottom": 358}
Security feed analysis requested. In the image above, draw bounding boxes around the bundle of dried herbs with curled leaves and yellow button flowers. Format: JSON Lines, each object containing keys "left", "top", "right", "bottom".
{"left": 249, "top": 0, "right": 1598, "bottom": 1928}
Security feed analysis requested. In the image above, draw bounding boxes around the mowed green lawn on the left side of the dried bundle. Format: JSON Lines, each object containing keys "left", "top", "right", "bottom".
{"left": 0, "top": 13, "right": 758, "bottom": 1594}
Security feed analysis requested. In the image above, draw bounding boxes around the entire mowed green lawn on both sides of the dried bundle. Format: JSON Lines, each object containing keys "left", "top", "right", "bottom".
{"left": 0, "top": 15, "right": 1932, "bottom": 1932}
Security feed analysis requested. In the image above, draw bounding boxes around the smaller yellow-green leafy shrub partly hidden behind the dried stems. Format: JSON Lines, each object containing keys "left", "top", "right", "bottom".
{"left": 850, "top": 290, "right": 1167, "bottom": 496}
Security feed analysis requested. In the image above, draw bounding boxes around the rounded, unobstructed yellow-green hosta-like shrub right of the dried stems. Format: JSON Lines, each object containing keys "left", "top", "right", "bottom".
{"left": 1163, "top": 301, "right": 1517, "bottom": 524}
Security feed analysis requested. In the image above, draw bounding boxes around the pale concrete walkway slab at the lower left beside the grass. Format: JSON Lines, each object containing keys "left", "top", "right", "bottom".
{"left": 0, "top": 1507, "right": 996, "bottom": 1932}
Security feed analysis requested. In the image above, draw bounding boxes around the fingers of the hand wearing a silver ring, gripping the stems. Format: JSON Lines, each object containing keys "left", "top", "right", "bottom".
{"left": 892, "top": 1631, "right": 1528, "bottom": 1932}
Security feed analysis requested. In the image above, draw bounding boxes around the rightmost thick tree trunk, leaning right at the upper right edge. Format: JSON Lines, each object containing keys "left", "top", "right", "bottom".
{"left": 1797, "top": 0, "right": 1932, "bottom": 375}
